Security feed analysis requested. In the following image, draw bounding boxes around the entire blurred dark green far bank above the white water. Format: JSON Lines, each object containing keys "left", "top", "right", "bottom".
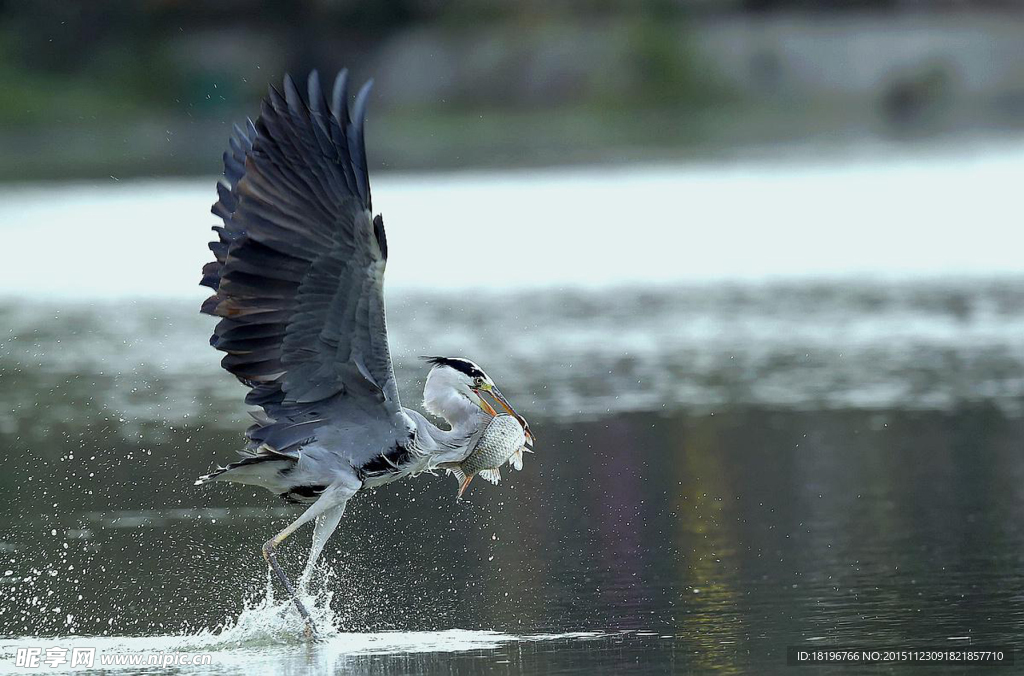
{"left": 0, "top": 3, "right": 1024, "bottom": 181}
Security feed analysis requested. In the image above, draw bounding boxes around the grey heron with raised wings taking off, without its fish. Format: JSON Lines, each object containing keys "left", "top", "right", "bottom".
{"left": 197, "top": 71, "right": 532, "bottom": 634}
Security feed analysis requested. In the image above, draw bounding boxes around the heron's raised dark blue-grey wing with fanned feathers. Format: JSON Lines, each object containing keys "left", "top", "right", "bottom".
{"left": 201, "top": 72, "right": 401, "bottom": 438}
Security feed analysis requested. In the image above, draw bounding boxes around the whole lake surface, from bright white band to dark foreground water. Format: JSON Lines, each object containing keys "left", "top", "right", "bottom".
{"left": 0, "top": 147, "right": 1024, "bottom": 674}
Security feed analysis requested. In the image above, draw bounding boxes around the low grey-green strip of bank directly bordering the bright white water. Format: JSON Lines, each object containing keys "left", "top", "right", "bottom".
{"left": 6, "top": 107, "right": 1024, "bottom": 183}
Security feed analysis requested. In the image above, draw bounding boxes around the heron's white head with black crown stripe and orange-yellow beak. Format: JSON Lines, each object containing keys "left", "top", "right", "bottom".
{"left": 423, "top": 356, "right": 534, "bottom": 445}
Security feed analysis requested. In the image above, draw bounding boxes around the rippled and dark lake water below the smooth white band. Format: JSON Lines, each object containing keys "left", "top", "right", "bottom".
{"left": 0, "top": 279, "right": 1024, "bottom": 673}
